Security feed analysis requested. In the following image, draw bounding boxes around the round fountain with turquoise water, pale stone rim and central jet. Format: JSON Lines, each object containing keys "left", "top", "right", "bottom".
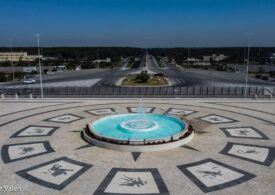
{"left": 83, "top": 100, "right": 194, "bottom": 152}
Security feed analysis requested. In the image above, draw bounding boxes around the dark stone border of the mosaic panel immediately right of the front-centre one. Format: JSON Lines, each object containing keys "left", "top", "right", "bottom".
{"left": 177, "top": 158, "right": 256, "bottom": 193}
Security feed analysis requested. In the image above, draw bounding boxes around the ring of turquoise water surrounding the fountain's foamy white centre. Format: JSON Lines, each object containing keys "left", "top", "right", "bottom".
{"left": 90, "top": 114, "right": 185, "bottom": 140}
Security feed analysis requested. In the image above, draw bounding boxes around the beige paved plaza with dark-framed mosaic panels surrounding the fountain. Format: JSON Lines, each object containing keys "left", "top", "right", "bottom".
{"left": 0, "top": 98, "right": 275, "bottom": 195}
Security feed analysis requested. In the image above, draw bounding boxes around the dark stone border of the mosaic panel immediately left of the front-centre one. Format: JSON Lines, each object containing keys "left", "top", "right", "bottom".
{"left": 16, "top": 157, "right": 93, "bottom": 190}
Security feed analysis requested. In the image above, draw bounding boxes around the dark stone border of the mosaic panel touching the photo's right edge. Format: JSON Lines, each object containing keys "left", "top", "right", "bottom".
{"left": 220, "top": 142, "right": 275, "bottom": 166}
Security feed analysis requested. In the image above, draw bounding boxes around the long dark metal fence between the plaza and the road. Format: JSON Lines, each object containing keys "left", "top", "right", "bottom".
{"left": 0, "top": 86, "right": 275, "bottom": 98}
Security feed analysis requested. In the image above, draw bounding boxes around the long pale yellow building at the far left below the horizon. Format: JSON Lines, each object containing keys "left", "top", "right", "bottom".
{"left": 0, "top": 52, "right": 42, "bottom": 62}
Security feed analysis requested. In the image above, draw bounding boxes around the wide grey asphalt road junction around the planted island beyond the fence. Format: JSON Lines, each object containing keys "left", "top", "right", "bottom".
{"left": 1, "top": 54, "right": 275, "bottom": 87}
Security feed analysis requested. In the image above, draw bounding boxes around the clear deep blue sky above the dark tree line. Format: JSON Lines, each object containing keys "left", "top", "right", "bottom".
{"left": 0, "top": 0, "right": 275, "bottom": 48}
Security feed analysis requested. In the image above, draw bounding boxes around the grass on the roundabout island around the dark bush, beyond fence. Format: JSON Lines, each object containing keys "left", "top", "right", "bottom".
{"left": 121, "top": 75, "right": 168, "bottom": 86}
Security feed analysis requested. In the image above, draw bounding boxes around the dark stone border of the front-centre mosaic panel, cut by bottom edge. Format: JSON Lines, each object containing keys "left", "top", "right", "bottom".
{"left": 94, "top": 168, "right": 169, "bottom": 195}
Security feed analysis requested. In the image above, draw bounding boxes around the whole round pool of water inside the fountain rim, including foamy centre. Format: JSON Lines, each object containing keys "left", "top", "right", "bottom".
{"left": 89, "top": 114, "right": 186, "bottom": 141}
